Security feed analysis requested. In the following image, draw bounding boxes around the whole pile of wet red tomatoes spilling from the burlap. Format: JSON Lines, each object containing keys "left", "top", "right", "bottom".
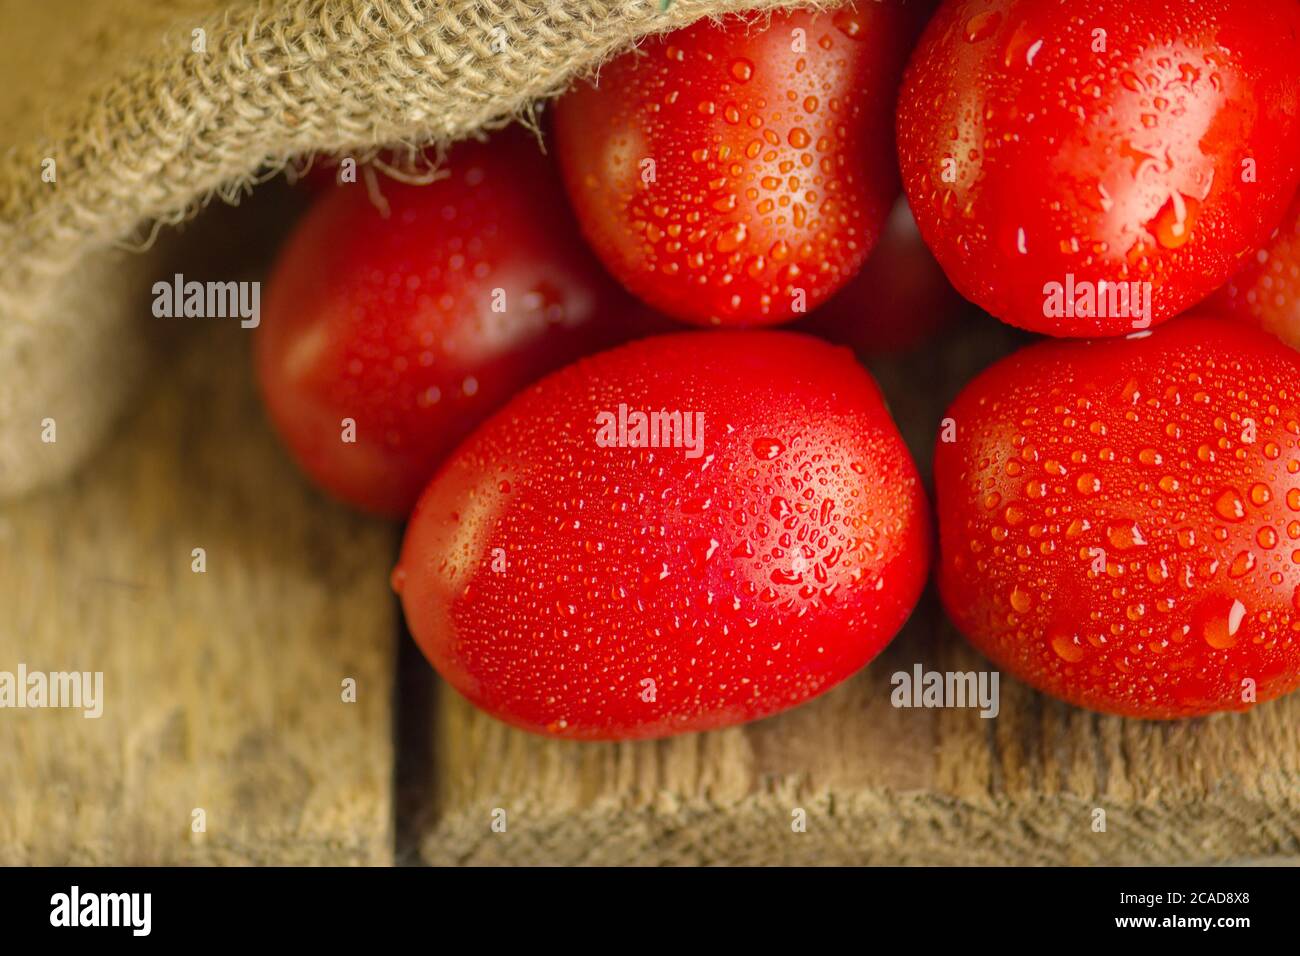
{"left": 256, "top": 0, "right": 1300, "bottom": 739}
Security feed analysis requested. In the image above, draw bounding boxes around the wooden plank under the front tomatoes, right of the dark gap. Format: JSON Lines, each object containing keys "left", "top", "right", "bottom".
{"left": 417, "top": 320, "right": 1300, "bottom": 864}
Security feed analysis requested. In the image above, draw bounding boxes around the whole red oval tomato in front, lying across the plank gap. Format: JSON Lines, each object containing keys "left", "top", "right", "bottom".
{"left": 394, "top": 332, "right": 930, "bottom": 739}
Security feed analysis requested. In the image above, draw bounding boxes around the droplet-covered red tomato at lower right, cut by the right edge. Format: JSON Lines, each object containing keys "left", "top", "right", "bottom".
{"left": 935, "top": 316, "right": 1300, "bottom": 718}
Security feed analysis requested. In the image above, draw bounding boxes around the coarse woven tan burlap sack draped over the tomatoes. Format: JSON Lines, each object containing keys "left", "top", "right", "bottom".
{"left": 0, "top": 0, "right": 816, "bottom": 497}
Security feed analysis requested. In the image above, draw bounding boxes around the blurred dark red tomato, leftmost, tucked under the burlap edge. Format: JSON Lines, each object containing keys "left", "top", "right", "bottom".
{"left": 255, "top": 133, "right": 644, "bottom": 518}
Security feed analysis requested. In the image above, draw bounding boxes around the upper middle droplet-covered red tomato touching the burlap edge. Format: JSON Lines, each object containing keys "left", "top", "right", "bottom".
{"left": 555, "top": 3, "right": 915, "bottom": 325}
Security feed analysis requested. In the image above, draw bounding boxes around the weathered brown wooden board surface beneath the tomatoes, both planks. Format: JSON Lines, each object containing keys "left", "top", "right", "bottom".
{"left": 0, "top": 190, "right": 1300, "bottom": 864}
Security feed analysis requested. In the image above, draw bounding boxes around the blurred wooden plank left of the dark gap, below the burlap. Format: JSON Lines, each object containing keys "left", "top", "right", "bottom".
{"left": 0, "top": 321, "right": 397, "bottom": 865}
